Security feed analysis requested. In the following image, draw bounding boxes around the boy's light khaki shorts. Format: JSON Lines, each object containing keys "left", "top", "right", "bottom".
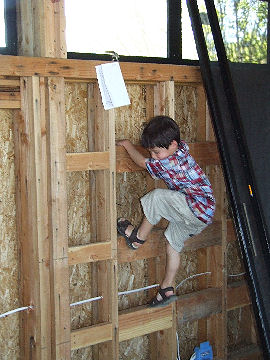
{"left": 141, "top": 189, "right": 207, "bottom": 252}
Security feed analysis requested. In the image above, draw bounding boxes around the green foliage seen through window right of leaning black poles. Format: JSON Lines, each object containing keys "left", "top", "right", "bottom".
{"left": 204, "top": 0, "right": 268, "bottom": 64}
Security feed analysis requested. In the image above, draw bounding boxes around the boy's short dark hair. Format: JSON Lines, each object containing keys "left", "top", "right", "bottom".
{"left": 141, "top": 115, "right": 180, "bottom": 149}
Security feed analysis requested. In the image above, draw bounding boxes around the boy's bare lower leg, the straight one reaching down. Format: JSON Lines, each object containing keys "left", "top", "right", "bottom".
{"left": 157, "top": 242, "right": 180, "bottom": 301}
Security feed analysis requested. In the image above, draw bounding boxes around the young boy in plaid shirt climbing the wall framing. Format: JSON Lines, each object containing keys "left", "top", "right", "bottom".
{"left": 117, "top": 116, "right": 215, "bottom": 307}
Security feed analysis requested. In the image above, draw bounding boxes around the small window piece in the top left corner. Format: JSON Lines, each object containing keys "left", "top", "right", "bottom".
{"left": 0, "top": 0, "right": 17, "bottom": 55}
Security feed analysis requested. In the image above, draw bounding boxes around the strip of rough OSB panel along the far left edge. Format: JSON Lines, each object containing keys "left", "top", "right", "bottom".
{"left": 0, "top": 110, "right": 19, "bottom": 359}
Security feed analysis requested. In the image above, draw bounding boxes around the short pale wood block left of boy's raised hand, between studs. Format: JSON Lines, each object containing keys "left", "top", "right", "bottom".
{"left": 66, "top": 151, "right": 110, "bottom": 171}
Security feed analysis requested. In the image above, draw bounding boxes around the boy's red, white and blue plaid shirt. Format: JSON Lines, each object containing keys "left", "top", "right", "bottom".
{"left": 146, "top": 141, "right": 215, "bottom": 224}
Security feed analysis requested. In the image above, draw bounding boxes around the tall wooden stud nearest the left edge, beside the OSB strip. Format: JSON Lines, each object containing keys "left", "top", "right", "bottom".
{"left": 15, "top": 77, "right": 51, "bottom": 360}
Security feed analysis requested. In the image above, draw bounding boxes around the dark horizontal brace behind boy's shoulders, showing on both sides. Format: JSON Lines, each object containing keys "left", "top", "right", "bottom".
{"left": 116, "top": 142, "right": 220, "bottom": 173}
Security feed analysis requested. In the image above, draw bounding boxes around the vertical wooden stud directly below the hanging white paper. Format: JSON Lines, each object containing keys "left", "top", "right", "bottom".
{"left": 89, "top": 85, "right": 119, "bottom": 360}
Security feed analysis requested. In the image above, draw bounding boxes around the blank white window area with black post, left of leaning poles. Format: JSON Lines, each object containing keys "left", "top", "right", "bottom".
{"left": 65, "top": 0, "right": 197, "bottom": 63}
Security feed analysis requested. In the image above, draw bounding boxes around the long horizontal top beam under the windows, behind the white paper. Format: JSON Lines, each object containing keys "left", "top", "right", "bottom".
{"left": 0, "top": 55, "right": 202, "bottom": 83}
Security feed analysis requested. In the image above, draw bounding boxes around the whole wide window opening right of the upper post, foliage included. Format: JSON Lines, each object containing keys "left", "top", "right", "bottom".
{"left": 65, "top": 0, "right": 269, "bottom": 64}
